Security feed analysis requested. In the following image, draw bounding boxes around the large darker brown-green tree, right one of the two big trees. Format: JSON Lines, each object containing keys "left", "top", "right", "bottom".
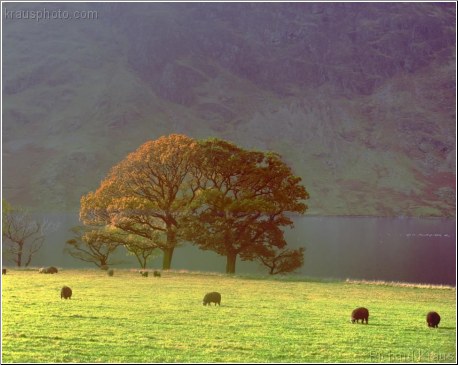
{"left": 183, "top": 139, "right": 308, "bottom": 273}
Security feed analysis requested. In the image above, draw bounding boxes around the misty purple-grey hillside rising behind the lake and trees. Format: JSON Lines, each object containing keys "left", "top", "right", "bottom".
{"left": 2, "top": 3, "right": 456, "bottom": 216}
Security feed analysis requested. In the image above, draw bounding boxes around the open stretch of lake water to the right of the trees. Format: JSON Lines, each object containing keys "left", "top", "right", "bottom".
{"left": 290, "top": 217, "right": 456, "bottom": 285}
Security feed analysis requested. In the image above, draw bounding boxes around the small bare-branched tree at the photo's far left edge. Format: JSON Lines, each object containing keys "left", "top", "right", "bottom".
{"left": 2, "top": 201, "right": 50, "bottom": 267}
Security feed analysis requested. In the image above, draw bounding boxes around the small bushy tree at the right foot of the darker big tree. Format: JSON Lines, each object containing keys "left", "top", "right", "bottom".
{"left": 258, "top": 247, "right": 305, "bottom": 275}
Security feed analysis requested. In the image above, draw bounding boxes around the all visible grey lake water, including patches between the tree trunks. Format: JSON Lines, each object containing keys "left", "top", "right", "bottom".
{"left": 12, "top": 213, "right": 456, "bottom": 285}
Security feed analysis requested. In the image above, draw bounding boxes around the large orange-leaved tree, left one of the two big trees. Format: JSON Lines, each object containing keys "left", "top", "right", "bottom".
{"left": 80, "top": 134, "right": 198, "bottom": 269}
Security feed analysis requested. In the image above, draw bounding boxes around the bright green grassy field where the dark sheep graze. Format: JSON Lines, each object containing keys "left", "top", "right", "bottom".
{"left": 2, "top": 270, "right": 456, "bottom": 363}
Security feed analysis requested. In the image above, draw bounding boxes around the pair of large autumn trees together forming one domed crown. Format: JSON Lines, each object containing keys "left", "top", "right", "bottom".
{"left": 80, "top": 135, "right": 309, "bottom": 273}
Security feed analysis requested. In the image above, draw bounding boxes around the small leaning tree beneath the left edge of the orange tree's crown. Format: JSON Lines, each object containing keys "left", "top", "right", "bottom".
{"left": 65, "top": 226, "right": 122, "bottom": 268}
